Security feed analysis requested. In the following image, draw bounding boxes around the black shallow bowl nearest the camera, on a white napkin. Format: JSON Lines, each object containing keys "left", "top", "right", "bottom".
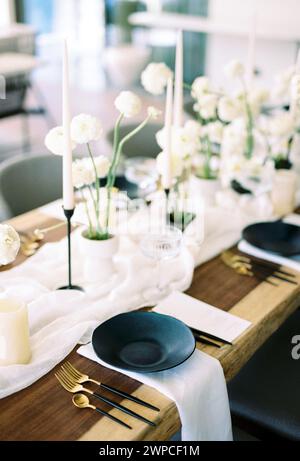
{"left": 92, "top": 312, "right": 196, "bottom": 373}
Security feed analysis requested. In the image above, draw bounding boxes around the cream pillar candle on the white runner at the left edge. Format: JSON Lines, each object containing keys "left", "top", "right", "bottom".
{"left": 0, "top": 299, "right": 31, "bottom": 366}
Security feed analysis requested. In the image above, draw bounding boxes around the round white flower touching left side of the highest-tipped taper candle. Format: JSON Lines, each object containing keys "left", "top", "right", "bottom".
{"left": 141, "top": 62, "right": 173, "bottom": 95}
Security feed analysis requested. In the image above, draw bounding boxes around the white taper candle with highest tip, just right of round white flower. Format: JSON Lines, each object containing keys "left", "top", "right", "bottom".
{"left": 174, "top": 30, "right": 183, "bottom": 128}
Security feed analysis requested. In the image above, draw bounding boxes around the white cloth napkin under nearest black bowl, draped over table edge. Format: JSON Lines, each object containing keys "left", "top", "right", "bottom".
{"left": 78, "top": 344, "right": 232, "bottom": 441}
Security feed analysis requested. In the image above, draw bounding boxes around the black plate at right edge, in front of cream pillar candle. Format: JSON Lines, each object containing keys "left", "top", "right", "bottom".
{"left": 243, "top": 221, "right": 300, "bottom": 256}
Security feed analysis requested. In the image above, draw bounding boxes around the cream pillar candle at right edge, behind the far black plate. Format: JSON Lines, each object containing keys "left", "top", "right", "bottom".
{"left": 271, "top": 170, "right": 297, "bottom": 217}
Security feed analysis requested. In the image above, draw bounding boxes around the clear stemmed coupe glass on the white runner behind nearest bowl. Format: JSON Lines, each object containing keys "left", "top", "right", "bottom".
{"left": 140, "top": 226, "right": 182, "bottom": 293}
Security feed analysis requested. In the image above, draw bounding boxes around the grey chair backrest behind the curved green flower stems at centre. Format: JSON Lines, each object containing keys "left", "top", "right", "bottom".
{"left": 107, "top": 123, "right": 162, "bottom": 158}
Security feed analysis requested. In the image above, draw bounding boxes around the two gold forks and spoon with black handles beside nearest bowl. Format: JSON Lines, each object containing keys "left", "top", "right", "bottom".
{"left": 55, "top": 362, "right": 160, "bottom": 429}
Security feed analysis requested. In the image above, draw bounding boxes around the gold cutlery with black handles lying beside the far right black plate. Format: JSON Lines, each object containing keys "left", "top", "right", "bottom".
{"left": 221, "top": 250, "right": 298, "bottom": 287}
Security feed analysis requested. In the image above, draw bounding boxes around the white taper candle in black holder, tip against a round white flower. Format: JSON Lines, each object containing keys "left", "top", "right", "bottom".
{"left": 162, "top": 78, "right": 173, "bottom": 189}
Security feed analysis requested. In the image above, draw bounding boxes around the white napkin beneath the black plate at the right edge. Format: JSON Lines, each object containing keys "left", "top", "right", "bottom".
{"left": 238, "top": 214, "right": 300, "bottom": 272}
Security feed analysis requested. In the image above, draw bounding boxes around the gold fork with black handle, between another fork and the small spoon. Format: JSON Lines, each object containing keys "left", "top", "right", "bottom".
{"left": 55, "top": 369, "right": 156, "bottom": 426}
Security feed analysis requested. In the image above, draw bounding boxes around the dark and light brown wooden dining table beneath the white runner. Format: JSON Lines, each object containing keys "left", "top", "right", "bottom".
{"left": 0, "top": 210, "right": 300, "bottom": 441}
